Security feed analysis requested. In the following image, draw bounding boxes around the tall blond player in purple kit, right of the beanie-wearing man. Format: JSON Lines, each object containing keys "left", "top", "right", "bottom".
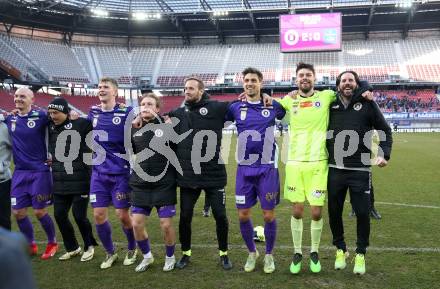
{"left": 88, "top": 77, "right": 137, "bottom": 269}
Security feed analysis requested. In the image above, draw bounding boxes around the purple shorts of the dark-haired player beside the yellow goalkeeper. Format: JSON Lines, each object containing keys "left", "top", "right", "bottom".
{"left": 235, "top": 166, "right": 280, "bottom": 210}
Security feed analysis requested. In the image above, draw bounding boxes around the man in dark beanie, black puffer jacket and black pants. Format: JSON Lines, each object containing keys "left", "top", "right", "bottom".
{"left": 48, "top": 98, "right": 97, "bottom": 261}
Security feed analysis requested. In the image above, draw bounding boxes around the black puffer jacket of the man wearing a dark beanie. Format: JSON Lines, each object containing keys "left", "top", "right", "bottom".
{"left": 49, "top": 118, "right": 92, "bottom": 195}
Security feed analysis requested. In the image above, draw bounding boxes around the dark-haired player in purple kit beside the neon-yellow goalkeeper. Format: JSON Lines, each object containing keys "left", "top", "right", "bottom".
{"left": 226, "top": 67, "right": 286, "bottom": 273}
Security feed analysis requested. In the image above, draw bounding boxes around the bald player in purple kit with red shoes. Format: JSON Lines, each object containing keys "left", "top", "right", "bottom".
{"left": 5, "top": 87, "right": 58, "bottom": 260}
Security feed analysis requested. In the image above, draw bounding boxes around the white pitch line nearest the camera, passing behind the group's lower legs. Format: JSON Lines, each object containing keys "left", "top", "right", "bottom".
{"left": 36, "top": 241, "right": 440, "bottom": 253}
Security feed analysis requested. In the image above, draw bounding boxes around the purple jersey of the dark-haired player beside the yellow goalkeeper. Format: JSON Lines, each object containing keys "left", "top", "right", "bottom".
{"left": 226, "top": 101, "right": 286, "bottom": 167}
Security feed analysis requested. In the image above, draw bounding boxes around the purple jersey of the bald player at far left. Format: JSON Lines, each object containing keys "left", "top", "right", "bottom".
{"left": 5, "top": 109, "right": 49, "bottom": 172}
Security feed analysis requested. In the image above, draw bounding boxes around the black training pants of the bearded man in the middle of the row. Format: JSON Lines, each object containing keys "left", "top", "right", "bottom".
{"left": 179, "top": 187, "right": 228, "bottom": 251}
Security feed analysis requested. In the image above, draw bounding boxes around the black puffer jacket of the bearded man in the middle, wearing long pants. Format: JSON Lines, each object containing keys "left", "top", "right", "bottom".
{"left": 169, "top": 93, "right": 229, "bottom": 188}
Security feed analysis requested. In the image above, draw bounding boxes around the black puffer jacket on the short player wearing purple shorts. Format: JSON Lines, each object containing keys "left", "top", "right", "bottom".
{"left": 130, "top": 118, "right": 177, "bottom": 207}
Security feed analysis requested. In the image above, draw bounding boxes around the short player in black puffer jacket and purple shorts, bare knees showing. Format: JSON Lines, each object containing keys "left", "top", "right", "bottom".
{"left": 130, "top": 93, "right": 177, "bottom": 272}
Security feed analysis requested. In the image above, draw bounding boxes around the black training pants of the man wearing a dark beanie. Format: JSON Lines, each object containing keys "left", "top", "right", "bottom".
{"left": 53, "top": 194, "right": 98, "bottom": 252}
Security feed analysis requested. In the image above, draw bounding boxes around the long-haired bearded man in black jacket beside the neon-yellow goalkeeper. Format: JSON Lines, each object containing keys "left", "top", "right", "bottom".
{"left": 327, "top": 71, "right": 392, "bottom": 275}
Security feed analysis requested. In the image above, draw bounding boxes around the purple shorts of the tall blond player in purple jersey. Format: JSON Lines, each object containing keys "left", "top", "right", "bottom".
{"left": 90, "top": 171, "right": 131, "bottom": 209}
